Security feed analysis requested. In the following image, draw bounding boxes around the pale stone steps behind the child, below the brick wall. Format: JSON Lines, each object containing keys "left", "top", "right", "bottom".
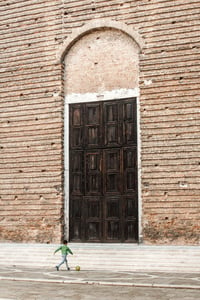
{"left": 0, "top": 243, "right": 200, "bottom": 273}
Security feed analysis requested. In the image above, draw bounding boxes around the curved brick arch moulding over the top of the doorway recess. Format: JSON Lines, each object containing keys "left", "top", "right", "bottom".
{"left": 57, "top": 20, "right": 144, "bottom": 63}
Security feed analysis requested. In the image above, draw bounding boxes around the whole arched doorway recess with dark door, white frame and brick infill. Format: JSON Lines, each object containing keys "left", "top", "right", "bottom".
{"left": 60, "top": 22, "right": 143, "bottom": 242}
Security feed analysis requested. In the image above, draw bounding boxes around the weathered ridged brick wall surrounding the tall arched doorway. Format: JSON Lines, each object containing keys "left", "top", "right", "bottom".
{"left": 0, "top": 0, "right": 200, "bottom": 244}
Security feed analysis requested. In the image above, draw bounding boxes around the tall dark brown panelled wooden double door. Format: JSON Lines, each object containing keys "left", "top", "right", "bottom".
{"left": 69, "top": 98, "right": 138, "bottom": 242}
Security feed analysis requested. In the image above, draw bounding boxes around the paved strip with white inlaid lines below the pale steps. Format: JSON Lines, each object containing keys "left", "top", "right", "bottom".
{"left": 0, "top": 266, "right": 200, "bottom": 290}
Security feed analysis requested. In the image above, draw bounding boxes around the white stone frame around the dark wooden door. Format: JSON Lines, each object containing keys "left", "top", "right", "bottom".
{"left": 63, "top": 88, "right": 143, "bottom": 243}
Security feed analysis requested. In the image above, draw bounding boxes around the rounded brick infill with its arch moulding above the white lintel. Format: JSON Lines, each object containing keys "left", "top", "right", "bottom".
{"left": 60, "top": 21, "right": 142, "bottom": 95}
